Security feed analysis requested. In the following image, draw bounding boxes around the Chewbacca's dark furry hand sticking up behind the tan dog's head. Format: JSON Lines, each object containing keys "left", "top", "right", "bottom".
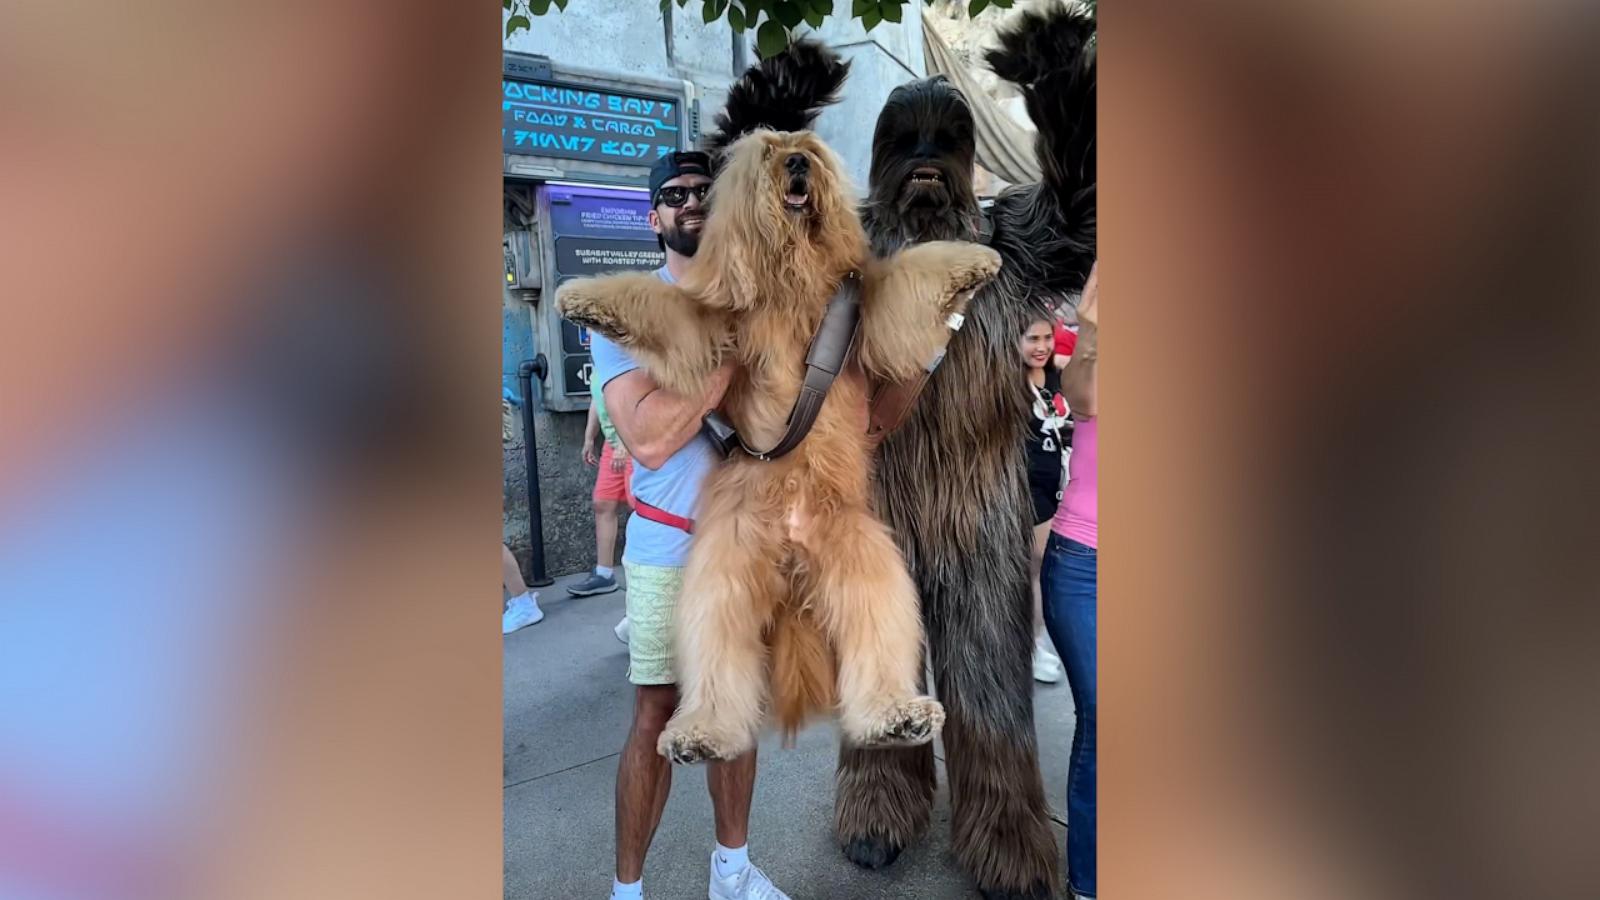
{"left": 702, "top": 40, "right": 850, "bottom": 167}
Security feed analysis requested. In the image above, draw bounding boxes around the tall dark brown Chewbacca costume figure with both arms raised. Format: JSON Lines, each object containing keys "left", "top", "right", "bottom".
{"left": 710, "top": 6, "right": 1096, "bottom": 900}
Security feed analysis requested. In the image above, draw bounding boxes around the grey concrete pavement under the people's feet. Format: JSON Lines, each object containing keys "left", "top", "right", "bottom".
{"left": 504, "top": 575, "right": 1072, "bottom": 900}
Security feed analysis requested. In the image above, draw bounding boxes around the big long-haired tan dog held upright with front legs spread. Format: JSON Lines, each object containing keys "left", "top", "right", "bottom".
{"left": 557, "top": 130, "right": 1000, "bottom": 762}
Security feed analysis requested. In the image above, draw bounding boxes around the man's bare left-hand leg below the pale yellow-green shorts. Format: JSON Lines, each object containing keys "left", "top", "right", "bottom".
{"left": 616, "top": 684, "right": 678, "bottom": 884}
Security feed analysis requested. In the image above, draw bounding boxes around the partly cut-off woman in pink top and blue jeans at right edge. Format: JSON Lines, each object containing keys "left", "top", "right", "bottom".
{"left": 1040, "top": 266, "right": 1099, "bottom": 897}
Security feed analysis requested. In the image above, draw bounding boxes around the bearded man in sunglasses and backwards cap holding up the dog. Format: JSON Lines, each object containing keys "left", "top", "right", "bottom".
{"left": 590, "top": 151, "right": 789, "bottom": 900}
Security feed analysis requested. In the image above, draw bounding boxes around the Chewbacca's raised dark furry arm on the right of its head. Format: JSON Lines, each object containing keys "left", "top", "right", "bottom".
{"left": 987, "top": 5, "right": 1096, "bottom": 293}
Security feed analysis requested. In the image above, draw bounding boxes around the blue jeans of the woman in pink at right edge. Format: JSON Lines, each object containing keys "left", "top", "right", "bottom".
{"left": 1040, "top": 532, "right": 1099, "bottom": 897}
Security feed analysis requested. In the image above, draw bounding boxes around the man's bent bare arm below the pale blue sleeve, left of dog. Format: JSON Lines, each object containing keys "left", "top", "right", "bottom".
{"left": 602, "top": 364, "right": 733, "bottom": 469}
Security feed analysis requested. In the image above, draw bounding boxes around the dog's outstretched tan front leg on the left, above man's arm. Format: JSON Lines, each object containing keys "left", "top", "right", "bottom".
{"left": 555, "top": 272, "right": 726, "bottom": 397}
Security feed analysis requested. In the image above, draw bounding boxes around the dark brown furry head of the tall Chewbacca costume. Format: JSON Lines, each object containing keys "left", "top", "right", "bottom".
{"left": 872, "top": 75, "right": 976, "bottom": 213}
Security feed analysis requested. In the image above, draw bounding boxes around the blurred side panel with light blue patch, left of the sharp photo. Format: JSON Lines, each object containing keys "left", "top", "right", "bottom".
{"left": 0, "top": 0, "right": 501, "bottom": 900}
